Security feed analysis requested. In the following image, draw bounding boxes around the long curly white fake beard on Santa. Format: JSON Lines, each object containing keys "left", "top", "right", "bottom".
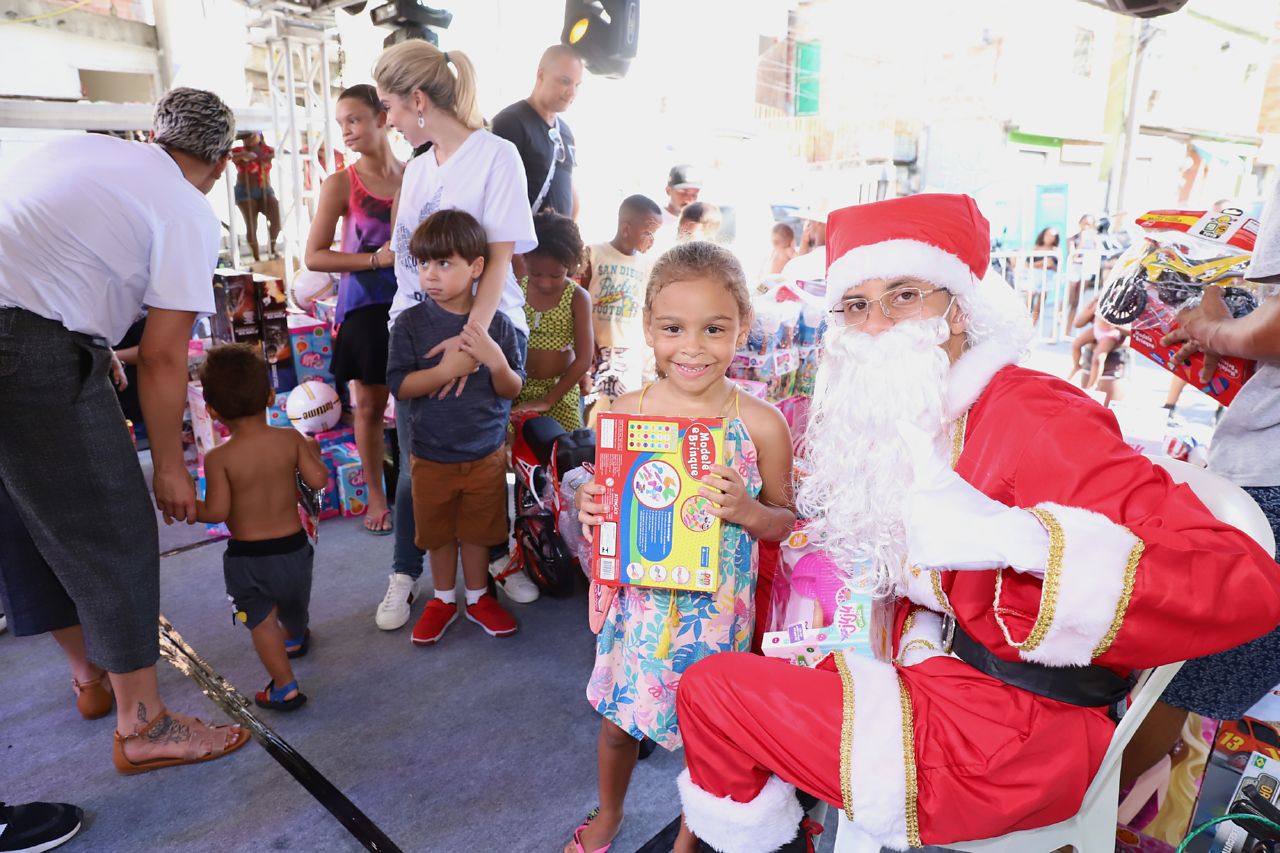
{"left": 796, "top": 318, "right": 951, "bottom": 596}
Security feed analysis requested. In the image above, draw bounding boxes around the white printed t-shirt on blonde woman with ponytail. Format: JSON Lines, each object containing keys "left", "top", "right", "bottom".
{"left": 390, "top": 131, "right": 538, "bottom": 336}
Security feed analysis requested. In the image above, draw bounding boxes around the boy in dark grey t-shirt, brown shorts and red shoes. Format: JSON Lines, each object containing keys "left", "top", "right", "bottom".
{"left": 387, "top": 210, "right": 525, "bottom": 646}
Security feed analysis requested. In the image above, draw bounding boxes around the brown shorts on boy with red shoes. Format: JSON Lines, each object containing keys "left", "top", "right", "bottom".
{"left": 410, "top": 447, "right": 507, "bottom": 551}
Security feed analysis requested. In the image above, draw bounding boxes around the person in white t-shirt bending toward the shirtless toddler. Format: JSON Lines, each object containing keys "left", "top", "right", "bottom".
{"left": 0, "top": 88, "right": 248, "bottom": 774}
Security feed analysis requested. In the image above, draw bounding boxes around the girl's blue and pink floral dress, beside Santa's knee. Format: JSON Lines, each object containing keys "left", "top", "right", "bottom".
{"left": 586, "top": 418, "right": 762, "bottom": 749}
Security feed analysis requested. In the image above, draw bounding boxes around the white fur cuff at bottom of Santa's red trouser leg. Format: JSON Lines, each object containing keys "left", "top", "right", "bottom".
{"left": 676, "top": 770, "right": 804, "bottom": 853}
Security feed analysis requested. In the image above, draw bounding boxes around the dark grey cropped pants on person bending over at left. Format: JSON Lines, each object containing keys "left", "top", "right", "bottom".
{"left": 0, "top": 307, "right": 160, "bottom": 672}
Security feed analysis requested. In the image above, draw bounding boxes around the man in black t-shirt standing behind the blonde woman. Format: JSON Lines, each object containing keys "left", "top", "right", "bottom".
{"left": 493, "top": 45, "right": 582, "bottom": 219}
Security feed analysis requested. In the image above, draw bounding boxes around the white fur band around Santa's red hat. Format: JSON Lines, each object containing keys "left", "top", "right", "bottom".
{"left": 827, "top": 240, "right": 977, "bottom": 309}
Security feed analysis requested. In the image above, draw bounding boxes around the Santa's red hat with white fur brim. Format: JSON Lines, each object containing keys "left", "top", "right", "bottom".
{"left": 827, "top": 193, "right": 991, "bottom": 307}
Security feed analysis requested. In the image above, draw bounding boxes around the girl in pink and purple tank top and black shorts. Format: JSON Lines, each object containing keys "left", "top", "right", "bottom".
{"left": 306, "top": 85, "right": 404, "bottom": 535}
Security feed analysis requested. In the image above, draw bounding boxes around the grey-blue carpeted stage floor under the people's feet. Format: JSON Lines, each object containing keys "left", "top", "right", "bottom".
{"left": 0, "top": 335, "right": 1213, "bottom": 853}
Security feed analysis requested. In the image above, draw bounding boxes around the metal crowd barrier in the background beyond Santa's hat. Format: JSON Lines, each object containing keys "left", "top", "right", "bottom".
{"left": 991, "top": 250, "right": 1103, "bottom": 343}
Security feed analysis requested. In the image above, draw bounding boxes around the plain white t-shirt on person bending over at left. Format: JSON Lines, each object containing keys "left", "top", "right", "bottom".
{"left": 0, "top": 134, "right": 220, "bottom": 345}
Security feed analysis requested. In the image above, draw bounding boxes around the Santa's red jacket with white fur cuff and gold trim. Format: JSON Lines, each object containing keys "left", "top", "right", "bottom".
{"left": 899, "top": 359, "right": 1280, "bottom": 675}
